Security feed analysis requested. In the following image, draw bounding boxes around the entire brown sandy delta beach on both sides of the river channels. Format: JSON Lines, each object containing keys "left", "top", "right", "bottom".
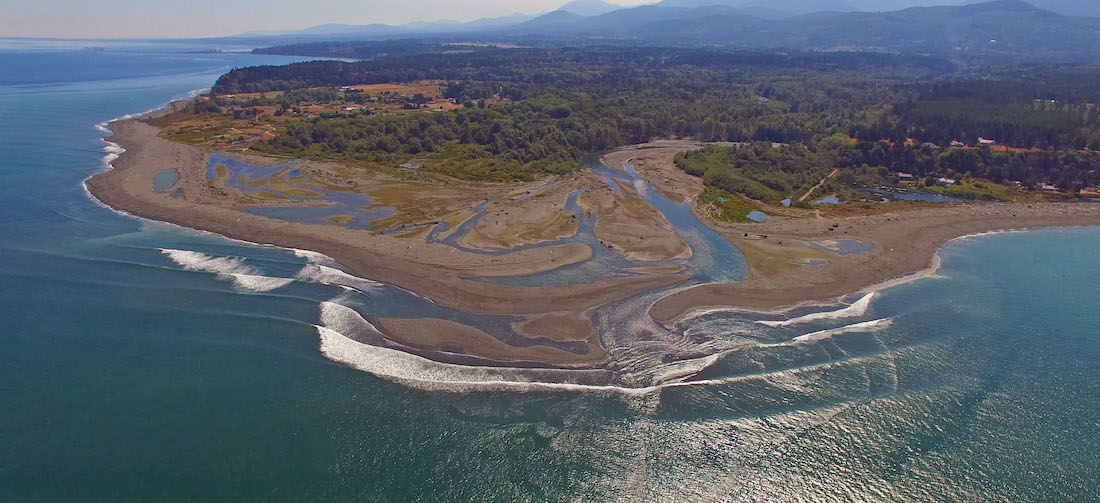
{"left": 87, "top": 115, "right": 1100, "bottom": 364}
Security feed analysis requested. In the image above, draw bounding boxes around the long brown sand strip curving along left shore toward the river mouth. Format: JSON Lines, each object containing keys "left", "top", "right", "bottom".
{"left": 88, "top": 120, "right": 686, "bottom": 330}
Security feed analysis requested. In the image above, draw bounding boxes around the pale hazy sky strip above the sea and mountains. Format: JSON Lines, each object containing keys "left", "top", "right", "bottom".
{"left": 0, "top": 0, "right": 653, "bottom": 37}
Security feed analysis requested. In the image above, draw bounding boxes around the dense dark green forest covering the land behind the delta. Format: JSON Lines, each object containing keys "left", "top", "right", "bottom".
{"left": 202, "top": 47, "right": 1100, "bottom": 190}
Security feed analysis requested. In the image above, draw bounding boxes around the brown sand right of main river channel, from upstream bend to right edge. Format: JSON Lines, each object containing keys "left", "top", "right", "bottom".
{"left": 601, "top": 141, "right": 1100, "bottom": 325}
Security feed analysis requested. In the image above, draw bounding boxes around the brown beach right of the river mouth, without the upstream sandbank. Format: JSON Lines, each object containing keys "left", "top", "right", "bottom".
{"left": 650, "top": 203, "right": 1100, "bottom": 322}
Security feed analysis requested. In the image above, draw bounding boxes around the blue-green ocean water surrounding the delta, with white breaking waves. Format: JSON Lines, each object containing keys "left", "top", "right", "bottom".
{"left": 0, "top": 41, "right": 1100, "bottom": 502}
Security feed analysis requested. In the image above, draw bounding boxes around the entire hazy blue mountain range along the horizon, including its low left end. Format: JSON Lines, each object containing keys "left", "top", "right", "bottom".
{"left": 229, "top": 0, "right": 1100, "bottom": 61}
